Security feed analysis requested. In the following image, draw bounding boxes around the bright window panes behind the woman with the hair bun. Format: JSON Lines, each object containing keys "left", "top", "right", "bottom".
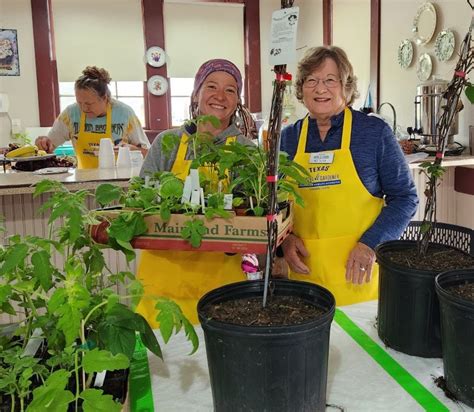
{"left": 59, "top": 81, "right": 145, "bottom": 127}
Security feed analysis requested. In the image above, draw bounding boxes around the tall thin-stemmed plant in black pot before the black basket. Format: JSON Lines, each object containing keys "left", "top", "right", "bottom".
{"left": 376, "top": 10, "right": 474, "bottom": 357}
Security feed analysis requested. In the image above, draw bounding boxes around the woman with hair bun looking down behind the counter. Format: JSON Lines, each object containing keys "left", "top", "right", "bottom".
{"left": 35, "top": 66, "right": 150, "bottom": 169}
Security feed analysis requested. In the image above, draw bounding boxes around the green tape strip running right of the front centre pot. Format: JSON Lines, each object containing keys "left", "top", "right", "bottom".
{"left": 334, "top": 309, "right": 449, "bottom": 412}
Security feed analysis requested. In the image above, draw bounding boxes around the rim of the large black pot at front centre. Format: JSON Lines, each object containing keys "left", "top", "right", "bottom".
{"left": 197, "top": 279, "right": 336, "bottom": 335}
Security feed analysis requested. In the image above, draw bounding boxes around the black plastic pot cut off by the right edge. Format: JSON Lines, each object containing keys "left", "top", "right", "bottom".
{"left": 435, "top": 269, "right": 474, "bottom": 407}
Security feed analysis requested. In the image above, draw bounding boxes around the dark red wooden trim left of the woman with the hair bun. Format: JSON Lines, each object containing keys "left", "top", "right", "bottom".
{"left": 31, "top": 0, "right": 59, "bottom": 127}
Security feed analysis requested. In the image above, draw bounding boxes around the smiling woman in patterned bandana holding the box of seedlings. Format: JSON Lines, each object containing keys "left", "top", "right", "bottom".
{"left": 137, "top": 59, "right": 253, "bottom": 325}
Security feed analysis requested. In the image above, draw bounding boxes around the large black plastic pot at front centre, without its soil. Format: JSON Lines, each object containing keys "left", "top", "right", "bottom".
{"left": 198, "top": 280, "right": 335, "bottom": 412}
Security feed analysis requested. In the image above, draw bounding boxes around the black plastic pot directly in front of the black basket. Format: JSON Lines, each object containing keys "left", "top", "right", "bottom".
{"left": 375, "top": 240, "right": 442, "bottom": 358}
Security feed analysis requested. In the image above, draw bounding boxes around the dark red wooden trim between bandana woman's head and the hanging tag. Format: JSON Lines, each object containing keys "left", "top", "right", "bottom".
{"left": 244, "top": 0, "right": 262, "bottom": 113}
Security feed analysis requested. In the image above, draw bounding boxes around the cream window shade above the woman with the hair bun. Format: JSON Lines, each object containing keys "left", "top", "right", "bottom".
{"left": 51, "top": 0, "right": 146, "bottom": 82}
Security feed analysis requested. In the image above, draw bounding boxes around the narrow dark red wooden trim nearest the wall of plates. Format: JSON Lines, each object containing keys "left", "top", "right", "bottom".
{"left": 370, "top": 0, "right": 381, "bottom": 110}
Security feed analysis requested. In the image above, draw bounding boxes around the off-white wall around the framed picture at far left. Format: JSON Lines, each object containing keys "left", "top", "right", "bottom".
{"left": 0, "top": 0, "right": 39, "bottom": 129}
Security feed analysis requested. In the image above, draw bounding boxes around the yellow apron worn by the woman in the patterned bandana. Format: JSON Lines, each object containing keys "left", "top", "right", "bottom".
{"left": 137, "top": 136, "right": 245, "bottom": 328}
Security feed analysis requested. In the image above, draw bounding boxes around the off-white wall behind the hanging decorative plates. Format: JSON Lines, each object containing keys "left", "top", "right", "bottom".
{"left": 380, "top": 0, "right": 474, "bottom": 145}
